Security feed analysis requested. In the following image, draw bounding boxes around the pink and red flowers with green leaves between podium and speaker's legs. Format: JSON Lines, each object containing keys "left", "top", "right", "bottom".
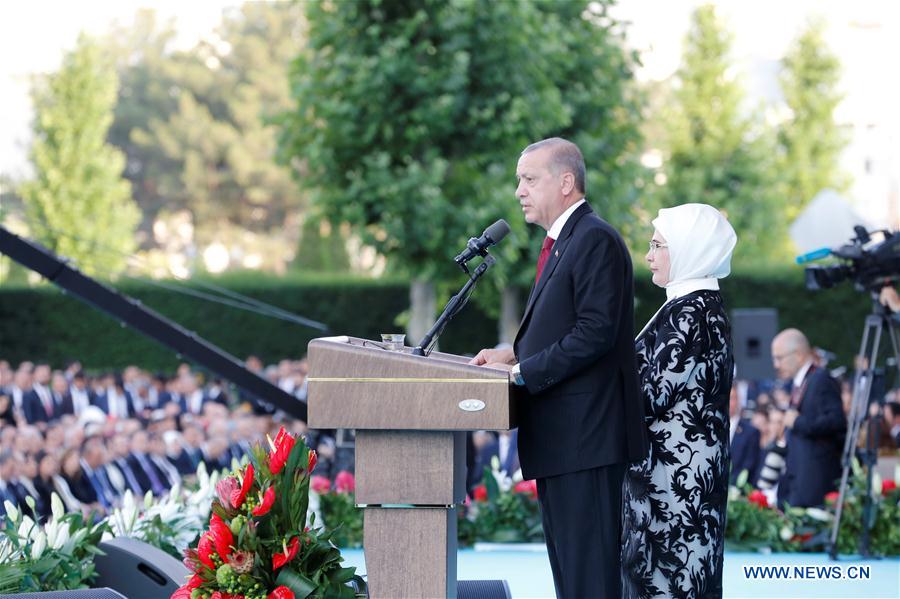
{"left": 458, "top": 459, "right": 544, "bottom": 545}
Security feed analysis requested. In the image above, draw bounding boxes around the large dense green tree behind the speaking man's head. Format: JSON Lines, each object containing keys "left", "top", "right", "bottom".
{"left": 281, "top": 0, "right": 637, "bottom": 334}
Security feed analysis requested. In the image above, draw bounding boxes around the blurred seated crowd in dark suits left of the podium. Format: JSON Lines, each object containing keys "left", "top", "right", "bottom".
{"left": 0, "top": 358, "right": 353, "bottom": 518}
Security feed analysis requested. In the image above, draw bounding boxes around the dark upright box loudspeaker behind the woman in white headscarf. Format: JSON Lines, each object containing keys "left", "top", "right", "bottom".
{"left": 731, "top": 308, "right": 778, "bottom": 381}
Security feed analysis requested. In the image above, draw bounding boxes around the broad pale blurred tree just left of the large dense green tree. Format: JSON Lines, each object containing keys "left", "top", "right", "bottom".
{"left": 123, "top": 2, "right": 304, "bottom": 242}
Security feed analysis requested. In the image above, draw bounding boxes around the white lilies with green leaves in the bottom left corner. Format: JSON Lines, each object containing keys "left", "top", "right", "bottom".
{"left": 0, "top": 493, "right": 107, "bottom": 593}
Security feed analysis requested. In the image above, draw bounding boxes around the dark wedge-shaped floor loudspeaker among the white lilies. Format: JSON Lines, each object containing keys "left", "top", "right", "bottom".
{"left": 94, "top": 537, "right": 190, "bottom": 599}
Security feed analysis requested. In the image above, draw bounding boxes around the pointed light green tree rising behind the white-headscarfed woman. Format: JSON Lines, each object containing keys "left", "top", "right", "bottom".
{"left": 655, "top": 6, "right": 787, "bottom": 260}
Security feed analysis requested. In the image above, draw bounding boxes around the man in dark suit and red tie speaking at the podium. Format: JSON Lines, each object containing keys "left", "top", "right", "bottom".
{"left": 471, "top": 138, "right": 647, "bottom": 599}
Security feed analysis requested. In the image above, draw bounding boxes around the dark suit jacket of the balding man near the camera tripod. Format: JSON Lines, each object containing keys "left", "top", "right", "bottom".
{"left": 778, "top": 368, "right": 847, "bottom": 507}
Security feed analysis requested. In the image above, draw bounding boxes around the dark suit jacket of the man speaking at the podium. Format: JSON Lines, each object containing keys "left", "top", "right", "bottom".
{"left": 513, "top": 203, "right": 647, "bottom": 479}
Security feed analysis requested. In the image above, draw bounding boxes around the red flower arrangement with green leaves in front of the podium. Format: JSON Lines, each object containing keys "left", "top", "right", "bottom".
{"left": 172, "top": 428, "right": 366, "bottom": 599}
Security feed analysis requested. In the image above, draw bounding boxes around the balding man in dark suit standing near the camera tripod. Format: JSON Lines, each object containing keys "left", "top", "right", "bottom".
{"left": 772, "top": 329, "right": 847, "bottom": 507}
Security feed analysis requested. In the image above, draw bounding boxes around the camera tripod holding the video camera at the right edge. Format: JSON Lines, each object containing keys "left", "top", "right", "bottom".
{"left": 828, "top": 292, "right": 900, "bottom": 559}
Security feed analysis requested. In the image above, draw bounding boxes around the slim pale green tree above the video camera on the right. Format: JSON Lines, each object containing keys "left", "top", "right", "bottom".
{"left": 778, "top": 20, "right": 850, "bottom": 220}
